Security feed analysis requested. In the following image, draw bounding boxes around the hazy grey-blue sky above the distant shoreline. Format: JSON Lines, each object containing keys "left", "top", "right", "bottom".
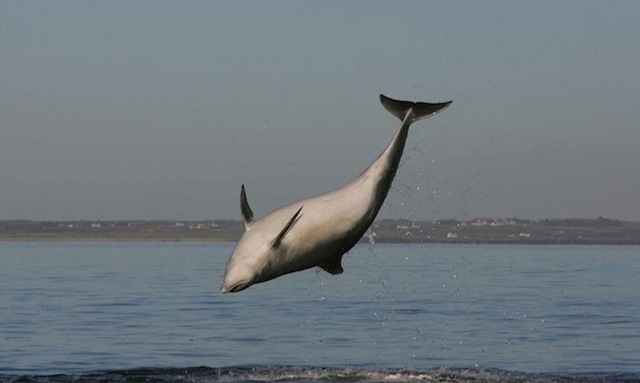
{"left": 0, "top": 0, "right": 640, "bottom": 221}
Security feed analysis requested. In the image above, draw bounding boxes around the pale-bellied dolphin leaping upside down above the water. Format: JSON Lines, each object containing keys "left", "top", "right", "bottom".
{"left": 220, "top": 94, "right": 451, "bottom": 294}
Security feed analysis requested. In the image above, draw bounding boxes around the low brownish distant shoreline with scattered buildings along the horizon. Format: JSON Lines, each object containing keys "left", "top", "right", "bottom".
{"left": 0, "top": 217, "right": 640, "bottom": 245}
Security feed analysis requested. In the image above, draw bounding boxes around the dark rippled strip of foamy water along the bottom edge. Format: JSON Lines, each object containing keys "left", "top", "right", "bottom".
{"left": 0, "top": 366, "right": 640, "bottom": 383}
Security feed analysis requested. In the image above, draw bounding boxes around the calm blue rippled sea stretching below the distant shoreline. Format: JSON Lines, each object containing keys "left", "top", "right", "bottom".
{"left": 0, "top": 242, "right": 640, "bottom": 383}
